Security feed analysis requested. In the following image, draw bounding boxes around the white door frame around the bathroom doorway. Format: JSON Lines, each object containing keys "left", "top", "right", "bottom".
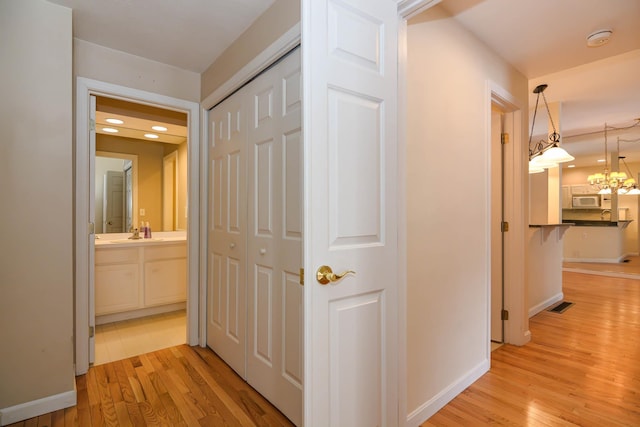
{"left": 75, "top": 77, "right": 200, "bottom": 375}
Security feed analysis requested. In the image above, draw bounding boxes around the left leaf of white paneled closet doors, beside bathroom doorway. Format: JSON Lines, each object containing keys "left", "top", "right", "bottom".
{"left": 207, "top": 91, "right": 247, "bottom": 377}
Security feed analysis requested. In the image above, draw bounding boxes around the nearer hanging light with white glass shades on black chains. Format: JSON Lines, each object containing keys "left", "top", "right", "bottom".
{"left": 529, "top": 84, "right": 575, "bottom": 173}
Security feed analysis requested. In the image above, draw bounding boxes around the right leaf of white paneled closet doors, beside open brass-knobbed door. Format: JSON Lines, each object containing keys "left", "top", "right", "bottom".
{"left": 247, "top": 49, "right": 303, "bottom": 425}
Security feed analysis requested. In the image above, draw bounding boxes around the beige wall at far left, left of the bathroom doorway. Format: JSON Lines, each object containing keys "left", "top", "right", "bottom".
{"left": 0, "top": 0, "right": 74, "bottom": 416}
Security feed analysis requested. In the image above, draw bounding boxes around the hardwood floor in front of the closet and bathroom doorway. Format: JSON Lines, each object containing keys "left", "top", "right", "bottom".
{"left": 11, "top": 345, "right": 293, "bottom": 427}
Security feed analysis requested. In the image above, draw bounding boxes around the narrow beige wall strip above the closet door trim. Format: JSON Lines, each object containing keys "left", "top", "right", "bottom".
{"left": 201, "top": 0, "right": 300, "bottom": 99}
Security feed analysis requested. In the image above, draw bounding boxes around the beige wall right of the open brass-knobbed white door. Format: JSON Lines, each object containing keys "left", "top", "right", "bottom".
{"left": 406, "top": 7, "right": 528, "bottom": 420}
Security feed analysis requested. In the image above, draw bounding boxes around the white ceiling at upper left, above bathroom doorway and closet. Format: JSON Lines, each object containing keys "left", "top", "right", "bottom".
{"left": 49, "top": 0, "right": 275, "bottom": 74}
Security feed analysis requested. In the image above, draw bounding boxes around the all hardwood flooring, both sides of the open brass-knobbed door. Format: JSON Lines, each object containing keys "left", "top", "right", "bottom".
{"left": 7, "top": 272, "right": 640, "bottom": 427}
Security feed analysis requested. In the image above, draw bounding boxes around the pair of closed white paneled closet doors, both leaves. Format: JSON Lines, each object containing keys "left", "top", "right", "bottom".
{"left": 207, "top": 49, "right": 303, "bottom": 425}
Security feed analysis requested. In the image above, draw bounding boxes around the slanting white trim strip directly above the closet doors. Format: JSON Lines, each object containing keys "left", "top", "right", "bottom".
{"left": 201, "top": 22, "right": 301, "bottom": 110}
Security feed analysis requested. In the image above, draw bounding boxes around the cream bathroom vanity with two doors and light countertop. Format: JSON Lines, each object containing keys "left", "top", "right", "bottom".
{"left": 95, "top": 233, "right": 187, "bottom": 324}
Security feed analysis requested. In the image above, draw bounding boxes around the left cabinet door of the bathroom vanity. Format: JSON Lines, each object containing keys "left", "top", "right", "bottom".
{"left": 95, "top": 264, "right": 140, "bottom": 315}
